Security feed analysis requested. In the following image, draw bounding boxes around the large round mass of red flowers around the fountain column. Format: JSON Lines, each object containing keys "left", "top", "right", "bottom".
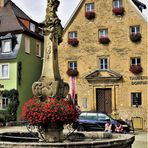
{"left": 22, "top": 97, "right": 80, "bottom": 130}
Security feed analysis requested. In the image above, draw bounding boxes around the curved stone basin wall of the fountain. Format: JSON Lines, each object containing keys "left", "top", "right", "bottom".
{"left": 0, "top": 132, "right": 135, "bottom": 148}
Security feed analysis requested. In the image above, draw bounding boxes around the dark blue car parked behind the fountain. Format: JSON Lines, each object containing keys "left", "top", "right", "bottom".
{"left": 73, "top": 112, "right": 131, "bottom": 132}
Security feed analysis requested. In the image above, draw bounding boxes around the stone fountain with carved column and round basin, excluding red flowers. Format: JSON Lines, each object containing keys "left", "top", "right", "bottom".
{"left": 0, "top": 0, "right": 135, "bottom": 148}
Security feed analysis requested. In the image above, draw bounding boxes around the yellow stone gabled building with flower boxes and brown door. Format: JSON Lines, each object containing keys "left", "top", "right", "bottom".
{"left": 59, "top": 0, "right": 148, "bottom": 129}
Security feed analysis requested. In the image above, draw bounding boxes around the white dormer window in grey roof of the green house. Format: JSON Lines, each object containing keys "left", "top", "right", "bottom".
{"left": 2, "top": 39, "right": 12, "bottom": 53}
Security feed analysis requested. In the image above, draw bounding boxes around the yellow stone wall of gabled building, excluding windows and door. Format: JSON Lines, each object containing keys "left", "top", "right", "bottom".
{"left": 59, "top": 0, "right": 148, "bottom": 129}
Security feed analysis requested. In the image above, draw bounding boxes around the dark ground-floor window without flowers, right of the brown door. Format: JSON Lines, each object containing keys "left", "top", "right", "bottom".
{"left": 131, "top": 92, "right": 142, "bottom": 106}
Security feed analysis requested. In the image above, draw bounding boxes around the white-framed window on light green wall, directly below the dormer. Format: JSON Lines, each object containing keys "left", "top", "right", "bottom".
{"left": 0, "top": 64, "right": 9, "bottom": 79}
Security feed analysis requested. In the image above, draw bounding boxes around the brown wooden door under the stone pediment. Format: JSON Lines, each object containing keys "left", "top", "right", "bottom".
{"left": 96, "top": 88, "right": 112, "bottom": 114}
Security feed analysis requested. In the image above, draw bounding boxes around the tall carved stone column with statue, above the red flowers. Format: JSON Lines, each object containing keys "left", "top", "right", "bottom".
{"left": 32, "top": 0, "right": 69, "bottom": 99}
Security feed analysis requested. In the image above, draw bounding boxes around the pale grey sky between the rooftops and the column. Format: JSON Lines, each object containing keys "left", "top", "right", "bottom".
{"left": 12, "top": 0, "right": 148, "bottom": 26}
